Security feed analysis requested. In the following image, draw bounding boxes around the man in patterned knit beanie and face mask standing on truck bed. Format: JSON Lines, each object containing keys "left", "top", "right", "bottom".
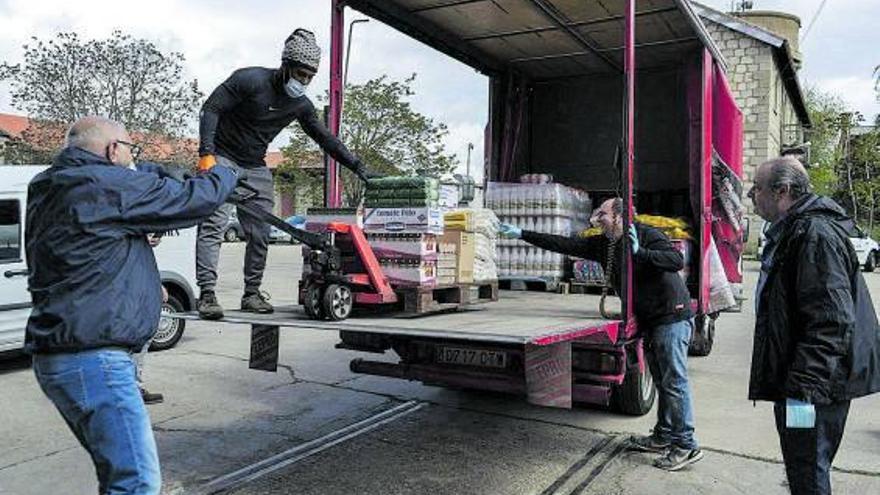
{"left": 196, "top": 29, "right": 374, "bottom": 320}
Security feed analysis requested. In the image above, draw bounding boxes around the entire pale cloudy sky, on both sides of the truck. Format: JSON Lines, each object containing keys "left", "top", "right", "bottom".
{"left": 0, "top": 0, "right": 880, "bottom": 178}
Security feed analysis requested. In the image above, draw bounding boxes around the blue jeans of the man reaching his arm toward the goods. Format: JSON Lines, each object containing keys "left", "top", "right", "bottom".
{"left": 645, "top": 320, "right": 697, "bottom": 449}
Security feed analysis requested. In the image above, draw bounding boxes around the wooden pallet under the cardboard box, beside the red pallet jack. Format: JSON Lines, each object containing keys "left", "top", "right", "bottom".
{"left": 394, "top": 282, "right": 498, "bottom": 316}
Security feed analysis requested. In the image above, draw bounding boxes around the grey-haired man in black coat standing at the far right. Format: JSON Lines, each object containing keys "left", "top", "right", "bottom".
{"left": 749, "top": 157, "right": 880, "bottom": 495}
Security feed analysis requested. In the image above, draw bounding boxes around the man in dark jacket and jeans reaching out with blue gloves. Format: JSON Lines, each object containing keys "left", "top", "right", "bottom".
{"left": 501, "top": 198, "right": 703, "bottom": 471}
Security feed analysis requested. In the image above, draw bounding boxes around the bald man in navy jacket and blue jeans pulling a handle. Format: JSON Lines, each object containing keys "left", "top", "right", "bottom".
{"left": 25, "top": 117, "right": 238, "bottom": 494}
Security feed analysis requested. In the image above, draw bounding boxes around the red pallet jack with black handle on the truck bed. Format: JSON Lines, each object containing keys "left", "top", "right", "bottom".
{"left": 229, "top": 183, "right": 398, "bottom": 321}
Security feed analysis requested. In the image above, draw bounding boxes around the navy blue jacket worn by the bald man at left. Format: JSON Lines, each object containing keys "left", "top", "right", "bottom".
{"left": 25, "top": 148, "right": 237, "bottom": 353}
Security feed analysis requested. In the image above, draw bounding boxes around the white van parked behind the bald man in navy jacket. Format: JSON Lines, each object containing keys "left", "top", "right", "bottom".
{"left": 0, "top": 165, "right": 196, "bottom": 353}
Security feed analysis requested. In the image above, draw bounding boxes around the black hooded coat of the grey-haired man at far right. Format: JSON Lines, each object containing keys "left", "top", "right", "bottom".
{"left": 749, "top": 195, "right": 880, "bottom": 404}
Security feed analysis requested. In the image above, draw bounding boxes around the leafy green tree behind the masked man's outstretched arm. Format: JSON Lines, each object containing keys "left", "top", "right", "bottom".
{"left": 282, "top": 74, "right": 457, "bottom": 205}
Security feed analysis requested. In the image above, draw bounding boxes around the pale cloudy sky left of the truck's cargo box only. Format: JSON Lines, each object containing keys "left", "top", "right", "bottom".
{"left": 0, "top": 0, "right": 488, "bottom": 169}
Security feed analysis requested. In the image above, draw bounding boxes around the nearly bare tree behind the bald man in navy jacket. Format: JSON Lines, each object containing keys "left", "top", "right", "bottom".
{"left": 0, "top": 31, "right": 203, "bottom": 164}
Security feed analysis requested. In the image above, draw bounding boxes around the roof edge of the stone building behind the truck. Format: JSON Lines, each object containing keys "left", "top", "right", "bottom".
{"left": 693, "top": 2, "right": 813, "bottom": 128}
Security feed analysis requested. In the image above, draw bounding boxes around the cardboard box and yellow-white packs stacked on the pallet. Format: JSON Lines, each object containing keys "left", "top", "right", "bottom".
{"left": 440, "top": 208, "right": 499, "bottom": 284}
